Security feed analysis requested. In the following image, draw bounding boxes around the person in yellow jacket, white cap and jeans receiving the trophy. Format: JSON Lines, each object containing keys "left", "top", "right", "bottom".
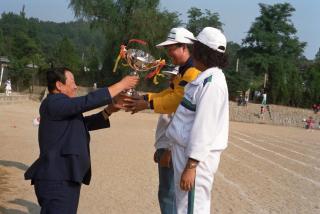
{"left": 126, "top": 27, "right": 200, "bottom": 214}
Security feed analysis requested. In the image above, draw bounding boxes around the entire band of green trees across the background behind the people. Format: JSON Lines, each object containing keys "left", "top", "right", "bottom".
{"left": 0, "top": 0, "right": 320, "bottom": 106}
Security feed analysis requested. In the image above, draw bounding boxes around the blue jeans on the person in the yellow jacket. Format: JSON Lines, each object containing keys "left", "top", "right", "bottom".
{"left": 156, "top": 149, "right": 177, "bottom": 214}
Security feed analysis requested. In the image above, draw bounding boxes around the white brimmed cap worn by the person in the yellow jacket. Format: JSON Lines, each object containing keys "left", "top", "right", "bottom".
{"left": 156, "top": 27, "right": 196, "bottom": 47}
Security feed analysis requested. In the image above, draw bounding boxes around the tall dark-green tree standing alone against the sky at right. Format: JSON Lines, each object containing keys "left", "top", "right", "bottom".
{"left": 241, "top": 3, "right": 305, "bottom": 105}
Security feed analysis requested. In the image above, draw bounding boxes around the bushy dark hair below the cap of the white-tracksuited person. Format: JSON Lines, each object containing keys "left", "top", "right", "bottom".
{"left": 192, "top": 41, "right": 228, "bottom": 69}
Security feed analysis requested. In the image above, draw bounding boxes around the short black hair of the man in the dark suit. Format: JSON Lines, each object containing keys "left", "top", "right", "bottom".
{"left": 47, "top": 67, "right": 71, "bottom": 93}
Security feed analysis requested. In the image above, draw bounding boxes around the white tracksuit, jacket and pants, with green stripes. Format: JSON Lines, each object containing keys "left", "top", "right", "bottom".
{"left": 166, "top": 67, "right": 229, "bottom": 214}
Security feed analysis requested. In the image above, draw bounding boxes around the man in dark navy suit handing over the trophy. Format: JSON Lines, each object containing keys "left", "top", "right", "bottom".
{"left": 25, "top": 68, "right": 138, "bottom": 214}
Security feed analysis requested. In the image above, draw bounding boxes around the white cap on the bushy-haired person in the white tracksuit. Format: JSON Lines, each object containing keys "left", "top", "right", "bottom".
{"left": 192, "top": 27, "right": 227, "bottom": 53}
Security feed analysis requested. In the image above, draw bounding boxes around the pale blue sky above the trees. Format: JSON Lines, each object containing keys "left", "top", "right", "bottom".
{"left": 0, "top": 0, "right": 320, "bottom": 59}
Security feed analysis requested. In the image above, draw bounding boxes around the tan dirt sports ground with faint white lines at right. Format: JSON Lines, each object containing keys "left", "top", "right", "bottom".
{"left": 0, "top": 101, "right": 320, "bottom": 214}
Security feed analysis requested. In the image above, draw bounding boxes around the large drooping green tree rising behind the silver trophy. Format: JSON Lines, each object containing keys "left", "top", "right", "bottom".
{"left": 70, "top": 0, "right": 179, "bottom": 87}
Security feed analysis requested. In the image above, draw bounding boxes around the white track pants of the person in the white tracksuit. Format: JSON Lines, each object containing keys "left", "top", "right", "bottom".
{"left": 172, "top": 144, "right": 222, "bottom": 214}
